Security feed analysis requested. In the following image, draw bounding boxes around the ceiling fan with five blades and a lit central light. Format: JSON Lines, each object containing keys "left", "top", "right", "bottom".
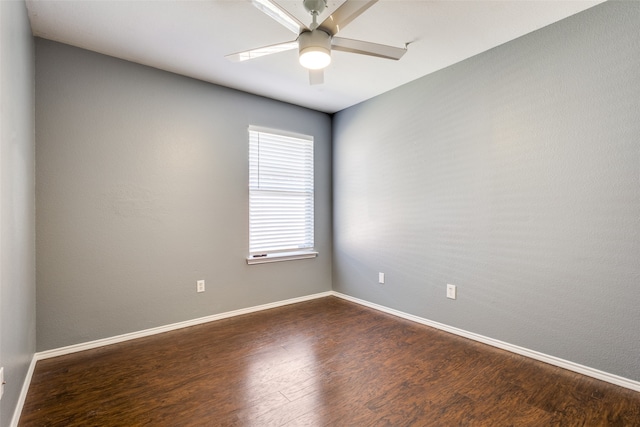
{"left": 226, "top": 0, "right": 408, "bottom": 85}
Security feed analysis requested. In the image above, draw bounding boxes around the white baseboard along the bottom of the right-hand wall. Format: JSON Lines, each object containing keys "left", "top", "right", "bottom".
{"left": 331, "top": 291, "right": 640, "bottom": 391}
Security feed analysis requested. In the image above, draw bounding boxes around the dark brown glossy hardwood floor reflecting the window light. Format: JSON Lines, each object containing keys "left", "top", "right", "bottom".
{"left": 20, "top": 297, "right": 640, "bottom": 426}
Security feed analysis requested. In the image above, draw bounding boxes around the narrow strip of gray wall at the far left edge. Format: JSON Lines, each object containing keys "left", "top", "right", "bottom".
{"left": 0, "top": 1, "right": 36, "bottom": 426}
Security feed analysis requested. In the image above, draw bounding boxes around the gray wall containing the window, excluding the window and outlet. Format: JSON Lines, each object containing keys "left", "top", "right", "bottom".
{"left": 36, "top": 39, "right": 332, "bottom": 351}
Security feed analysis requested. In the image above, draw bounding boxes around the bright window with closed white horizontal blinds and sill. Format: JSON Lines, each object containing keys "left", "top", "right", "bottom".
{"left": 247, "top": 126, "right": 317, "bottom": 264}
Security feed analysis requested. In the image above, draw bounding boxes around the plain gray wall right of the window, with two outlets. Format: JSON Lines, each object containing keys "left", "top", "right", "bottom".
{"left": 333, "top": 2, "right": 640, "bottom": 380}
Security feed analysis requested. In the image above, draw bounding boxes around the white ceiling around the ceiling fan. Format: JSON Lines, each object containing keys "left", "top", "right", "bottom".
{"left": 26, "top": 0, "right": 602, "bottom": 113}
